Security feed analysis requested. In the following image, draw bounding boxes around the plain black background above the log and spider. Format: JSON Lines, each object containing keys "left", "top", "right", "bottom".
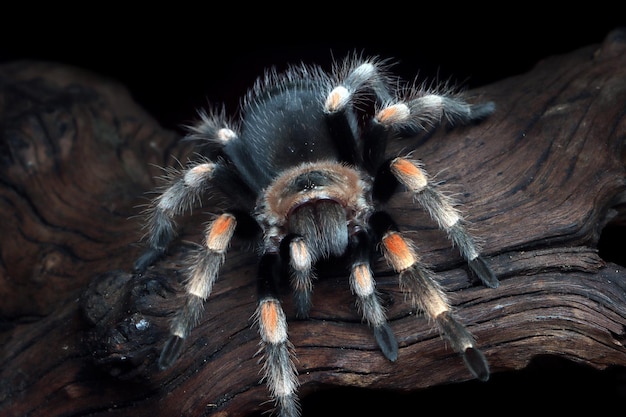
{"left": 0, "top": 12, "right": 626, "bottom": 130}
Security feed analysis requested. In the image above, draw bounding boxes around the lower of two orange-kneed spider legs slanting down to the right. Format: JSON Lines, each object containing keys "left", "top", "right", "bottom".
{"left": 371, "top": 212, "right": 489, "bottom": 381}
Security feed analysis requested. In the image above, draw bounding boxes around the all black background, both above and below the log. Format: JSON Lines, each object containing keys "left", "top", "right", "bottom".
{"left": 0, "top": 7, "right": 626, "bottom": 416}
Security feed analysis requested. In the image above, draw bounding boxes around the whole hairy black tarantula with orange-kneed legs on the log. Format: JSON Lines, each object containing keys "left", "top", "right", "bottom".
{"left": 135, "top": 57, "right": 498, "bottom": 416}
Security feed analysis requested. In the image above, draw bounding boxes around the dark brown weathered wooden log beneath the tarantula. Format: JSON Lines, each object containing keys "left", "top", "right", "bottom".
{"left": 0, "top": 31, "right": 626, "bottom": 417}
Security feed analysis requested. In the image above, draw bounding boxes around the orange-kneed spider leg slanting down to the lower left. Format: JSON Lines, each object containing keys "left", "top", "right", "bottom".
{"left": 159, "top": 213, "right": 237, "bottom": 369}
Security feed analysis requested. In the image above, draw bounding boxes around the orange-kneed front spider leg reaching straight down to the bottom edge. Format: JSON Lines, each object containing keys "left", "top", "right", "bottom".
{"left": 254, "top": 253, "right": 300, "bottom": 417}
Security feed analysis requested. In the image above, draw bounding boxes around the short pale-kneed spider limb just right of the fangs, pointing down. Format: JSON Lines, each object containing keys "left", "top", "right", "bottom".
{"left": 350, "top": 230, "right": 398, "bottom": 362}
